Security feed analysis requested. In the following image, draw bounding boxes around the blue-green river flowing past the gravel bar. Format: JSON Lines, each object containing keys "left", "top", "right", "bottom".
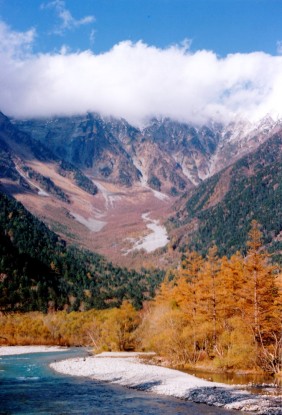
{"left": 0, "top": 349, "right": 247, "bottom": 415}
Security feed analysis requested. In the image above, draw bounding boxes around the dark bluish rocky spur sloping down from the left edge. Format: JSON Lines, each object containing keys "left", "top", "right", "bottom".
{"left": 0, "top": 113, "right": 98, "bottom": 201}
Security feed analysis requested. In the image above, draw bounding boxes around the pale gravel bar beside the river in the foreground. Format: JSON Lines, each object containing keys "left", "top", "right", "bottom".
{"left": 51, "top": 353, "right": 282, "bottom": 415}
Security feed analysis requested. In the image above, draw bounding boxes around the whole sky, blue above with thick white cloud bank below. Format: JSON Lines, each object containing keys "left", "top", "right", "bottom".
{"left": 0, "top": 0, "right": 282, "bottom": 125}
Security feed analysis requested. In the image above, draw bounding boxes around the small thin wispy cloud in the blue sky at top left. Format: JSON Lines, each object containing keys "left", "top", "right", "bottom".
{"left": 41, "top": 0, "right": 95, "bottom": 34}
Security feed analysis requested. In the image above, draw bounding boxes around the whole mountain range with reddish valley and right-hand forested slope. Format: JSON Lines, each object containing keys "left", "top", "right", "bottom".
{"left": 0, "top": 109, "right": 282, "bottom": 267}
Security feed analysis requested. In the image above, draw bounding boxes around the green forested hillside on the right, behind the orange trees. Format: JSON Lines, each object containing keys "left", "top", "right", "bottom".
{"left": 170, "top": 133, "right": 282, "bottom": 262}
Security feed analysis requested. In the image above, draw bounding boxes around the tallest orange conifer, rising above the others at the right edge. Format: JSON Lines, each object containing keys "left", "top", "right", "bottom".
{"left": 242, "top": 221, "right": 282, "bottom": 371}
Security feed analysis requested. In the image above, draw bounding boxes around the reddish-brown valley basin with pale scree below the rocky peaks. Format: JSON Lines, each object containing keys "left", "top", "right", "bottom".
{"left": 4, "top": 174, "right": 177, "bottom": 269}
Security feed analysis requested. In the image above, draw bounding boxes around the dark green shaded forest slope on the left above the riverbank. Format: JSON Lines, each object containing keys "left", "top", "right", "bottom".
{"left": 0, "top": 192, "right": 163, "bottom": 312}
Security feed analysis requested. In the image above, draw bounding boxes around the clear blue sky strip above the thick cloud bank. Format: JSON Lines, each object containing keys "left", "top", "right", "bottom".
{"left": 0, "top": 0, "right": 282, "bottom": 56}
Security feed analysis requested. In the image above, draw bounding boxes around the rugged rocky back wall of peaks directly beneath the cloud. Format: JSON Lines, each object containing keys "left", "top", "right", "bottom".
{"left": 15, "top": 114, "right": 281, "bottom": 196}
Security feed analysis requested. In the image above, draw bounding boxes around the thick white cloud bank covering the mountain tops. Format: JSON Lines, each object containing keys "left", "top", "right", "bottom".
{"left": 0, "top": 24, "right": 282, "bottom": 124}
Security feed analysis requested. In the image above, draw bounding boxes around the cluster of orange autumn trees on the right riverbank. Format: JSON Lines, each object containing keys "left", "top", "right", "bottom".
{"left": 140, "top": 221, "right": 282, "bottom": 372}
